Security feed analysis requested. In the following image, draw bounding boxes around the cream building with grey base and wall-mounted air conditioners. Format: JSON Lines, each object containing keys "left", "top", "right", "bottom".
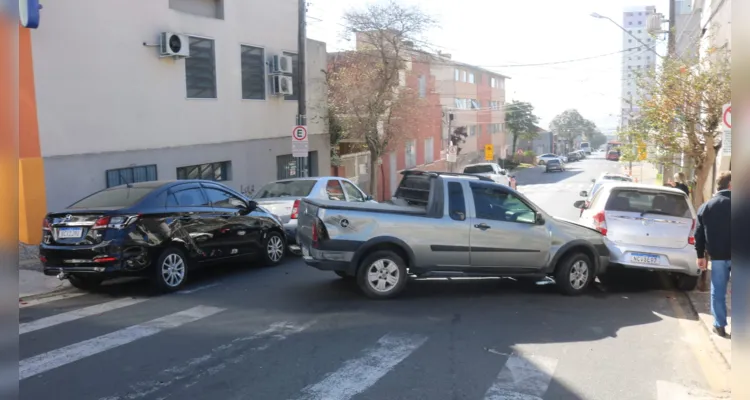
{"left": 14, "top": 0, "right": 330, "bottom": 244}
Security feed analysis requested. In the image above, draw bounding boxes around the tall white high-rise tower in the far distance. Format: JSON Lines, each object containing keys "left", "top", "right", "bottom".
{"left": 620, "top": 6, "right": 657, "bottom": 128}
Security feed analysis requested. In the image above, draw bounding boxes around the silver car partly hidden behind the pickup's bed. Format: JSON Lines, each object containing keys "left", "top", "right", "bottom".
{"left": 252, "top": 176, "right": 375, "bottom": 253}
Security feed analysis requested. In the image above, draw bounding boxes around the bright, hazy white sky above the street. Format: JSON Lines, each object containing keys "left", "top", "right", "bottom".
{"left": 308, "top": 0, "right": 668, "bottom": 133}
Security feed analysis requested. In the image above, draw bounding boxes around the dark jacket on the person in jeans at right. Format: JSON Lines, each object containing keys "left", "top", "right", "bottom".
{"left": 695, "top": 190, "right": 732, "bottom": 260}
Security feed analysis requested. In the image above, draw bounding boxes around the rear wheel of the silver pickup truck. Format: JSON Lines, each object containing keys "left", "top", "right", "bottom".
{"left": 357, "top": 250, "right": 408, "bottom": 299}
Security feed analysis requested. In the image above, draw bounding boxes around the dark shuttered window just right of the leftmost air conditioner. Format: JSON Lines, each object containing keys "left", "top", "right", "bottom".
{"left": 185, "top": 36, "right": 216, "bottom": 99}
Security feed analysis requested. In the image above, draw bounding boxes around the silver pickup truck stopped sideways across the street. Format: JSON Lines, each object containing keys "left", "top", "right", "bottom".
{"left": 297, "top": 171, "right": 609, "bottom": 298}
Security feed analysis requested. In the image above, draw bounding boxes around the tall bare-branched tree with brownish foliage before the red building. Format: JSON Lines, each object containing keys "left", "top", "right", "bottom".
{"left": 328, "top": 1, "right": 433, "bottom": 196}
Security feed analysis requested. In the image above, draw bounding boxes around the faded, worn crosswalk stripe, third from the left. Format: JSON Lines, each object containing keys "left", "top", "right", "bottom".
{"left": 100, "top": 320, "right": 316, "bottom": 400}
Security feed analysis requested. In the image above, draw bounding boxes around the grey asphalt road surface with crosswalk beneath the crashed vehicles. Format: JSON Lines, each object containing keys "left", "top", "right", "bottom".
{"left": 20, "top": 152, "right": 726, "bottom": 400}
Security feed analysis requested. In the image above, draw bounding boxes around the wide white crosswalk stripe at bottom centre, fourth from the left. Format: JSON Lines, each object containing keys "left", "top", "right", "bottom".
{"left": 299, "top": 333, "right": 427, "bottom": 400}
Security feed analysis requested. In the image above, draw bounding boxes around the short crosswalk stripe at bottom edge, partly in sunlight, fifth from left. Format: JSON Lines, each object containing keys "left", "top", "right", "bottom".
{"left": 484, "top": 353, "right": 557, "bottom": 400}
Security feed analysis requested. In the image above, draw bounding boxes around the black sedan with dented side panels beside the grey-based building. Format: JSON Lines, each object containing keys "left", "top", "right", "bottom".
{"left": 39, "top": 180, "right": 286, "bottom": 292}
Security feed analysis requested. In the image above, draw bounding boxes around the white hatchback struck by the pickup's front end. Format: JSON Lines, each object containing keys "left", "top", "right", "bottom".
{"left": 574, "top": 181, "right": 701, "bottom": 291}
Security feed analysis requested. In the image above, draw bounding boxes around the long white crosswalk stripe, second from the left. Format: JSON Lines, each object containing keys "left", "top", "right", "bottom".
{"left": 18, "top": 306, "right": 224, "bottom": 380}
